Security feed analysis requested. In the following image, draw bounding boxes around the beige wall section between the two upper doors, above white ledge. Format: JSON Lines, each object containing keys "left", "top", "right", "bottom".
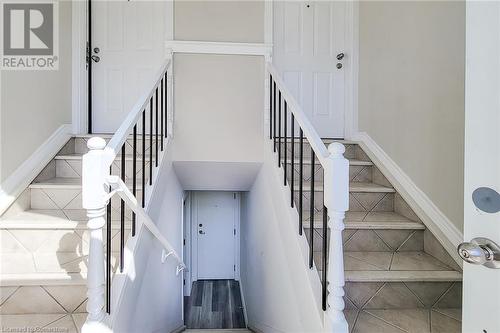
{"left": 174, "top": 0, "right": 264, "bottom": 43}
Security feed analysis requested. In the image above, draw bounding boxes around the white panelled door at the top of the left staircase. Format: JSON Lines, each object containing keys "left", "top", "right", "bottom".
{"left": 91, "top": 0, "right": 166, "bottom": 133}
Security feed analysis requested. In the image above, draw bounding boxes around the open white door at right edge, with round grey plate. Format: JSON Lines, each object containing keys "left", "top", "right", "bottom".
{"left": 462, "top": 1, "right": 500, "bottom": 333}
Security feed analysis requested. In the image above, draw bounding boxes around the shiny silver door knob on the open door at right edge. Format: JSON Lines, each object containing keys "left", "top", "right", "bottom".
{"left": 457, "top": 237, "right": 500, "bottom": 268}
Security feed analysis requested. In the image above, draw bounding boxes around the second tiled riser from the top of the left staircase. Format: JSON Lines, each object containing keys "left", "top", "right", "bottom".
{"left": 56, "top": 159, "right": 149, "bottom": 181}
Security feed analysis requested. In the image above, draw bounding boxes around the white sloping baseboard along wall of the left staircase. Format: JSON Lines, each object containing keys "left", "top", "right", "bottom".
{"left": 0, "top": 124, "right": 72, "bottom": 216}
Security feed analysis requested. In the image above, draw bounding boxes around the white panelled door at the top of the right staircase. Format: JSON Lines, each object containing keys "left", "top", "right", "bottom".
{"left": 273, "top": 1, "right": 348, "bottom": 138}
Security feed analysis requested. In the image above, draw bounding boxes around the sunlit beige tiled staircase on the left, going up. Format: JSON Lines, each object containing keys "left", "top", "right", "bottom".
{"left": 0, "top": 135, "right": 141, "bottom": 332}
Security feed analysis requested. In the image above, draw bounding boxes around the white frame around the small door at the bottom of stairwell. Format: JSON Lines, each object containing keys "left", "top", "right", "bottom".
{"left": 190, "top": 191, "right": 241, "bottom": 282}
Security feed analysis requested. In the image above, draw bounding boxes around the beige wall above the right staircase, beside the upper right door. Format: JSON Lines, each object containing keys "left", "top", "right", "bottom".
{"left": 359, "top": 1, "right": 465, "bottom": 230}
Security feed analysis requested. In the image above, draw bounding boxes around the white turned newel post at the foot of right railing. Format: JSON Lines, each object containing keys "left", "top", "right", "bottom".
{"left": 325, "top": 142, "right": 349, "bottom": 333}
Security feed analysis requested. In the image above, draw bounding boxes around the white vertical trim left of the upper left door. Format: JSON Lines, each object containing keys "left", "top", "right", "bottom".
{"left": 71, "top": 1, "right": 88, "bottom": 134}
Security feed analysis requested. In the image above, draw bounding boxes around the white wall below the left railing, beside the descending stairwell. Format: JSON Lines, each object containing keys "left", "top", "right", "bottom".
{"left": 113, "top": 151, "right": 183, "bottom": 333}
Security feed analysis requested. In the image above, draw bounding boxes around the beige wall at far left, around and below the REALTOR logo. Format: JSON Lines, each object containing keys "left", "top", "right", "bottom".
{"left": 0, "top": 1, "right": 72, "bottom": 182}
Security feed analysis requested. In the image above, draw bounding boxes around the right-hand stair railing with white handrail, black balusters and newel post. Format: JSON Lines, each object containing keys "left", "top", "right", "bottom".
{"left": 266, "top": 62, "right": 349, "bottom": 333}
